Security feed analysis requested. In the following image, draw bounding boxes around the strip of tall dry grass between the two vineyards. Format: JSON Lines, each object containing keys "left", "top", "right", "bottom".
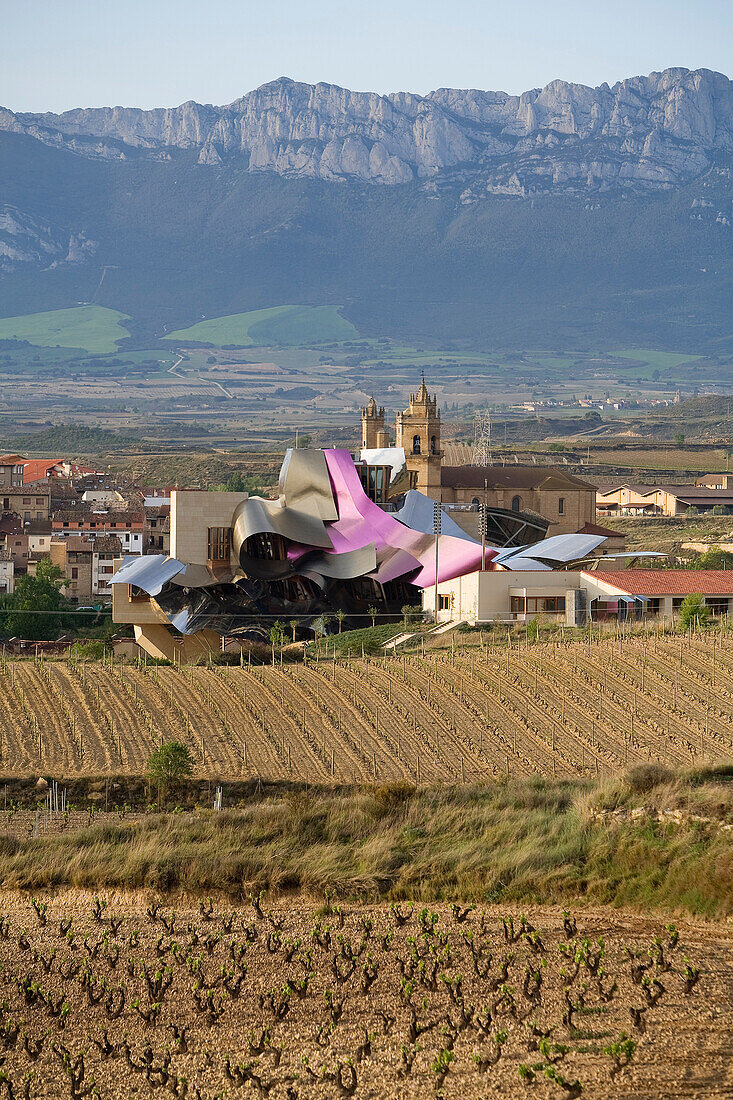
{"left": 0, "top": 771, "right": 733, "bottom": 915}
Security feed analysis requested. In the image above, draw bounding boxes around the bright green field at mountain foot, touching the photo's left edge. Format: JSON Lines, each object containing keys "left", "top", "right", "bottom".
{"left": 0, "top": 306, "right": 130, "bottom": 355}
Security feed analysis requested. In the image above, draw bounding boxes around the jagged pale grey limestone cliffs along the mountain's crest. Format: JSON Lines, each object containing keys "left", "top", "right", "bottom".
{"left": 0, "top": 68, "right": 733, "bottom": 192}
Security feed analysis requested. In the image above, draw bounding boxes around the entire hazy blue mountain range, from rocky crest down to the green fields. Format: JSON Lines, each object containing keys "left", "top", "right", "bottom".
{"left": 0, "top": 69, "right": 733, "bottom": 351}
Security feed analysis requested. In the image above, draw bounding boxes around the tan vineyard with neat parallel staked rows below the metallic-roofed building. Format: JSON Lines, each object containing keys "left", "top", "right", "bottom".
{"left": 0, "top": 633, "right": 733, "bottom": 783}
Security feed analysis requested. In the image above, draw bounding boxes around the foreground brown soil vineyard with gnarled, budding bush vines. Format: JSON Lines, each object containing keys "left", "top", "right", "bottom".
{"left": 0, "top": 891, "right": 733, "bottom": 1100}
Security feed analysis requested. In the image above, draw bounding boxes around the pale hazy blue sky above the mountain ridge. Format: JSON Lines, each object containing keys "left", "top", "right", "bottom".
{"left": 0, "top": 0, "right": 733, "bottom": 111}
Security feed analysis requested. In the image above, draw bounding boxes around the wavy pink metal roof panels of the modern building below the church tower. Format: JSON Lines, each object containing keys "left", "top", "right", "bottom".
{"left": 324, "top": 449, "right": 488, "bottom": 589}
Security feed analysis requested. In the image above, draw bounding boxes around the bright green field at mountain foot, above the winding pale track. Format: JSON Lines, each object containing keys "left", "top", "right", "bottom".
{"left": 165, "top": 306, "right": 359, "bottom": 348}
